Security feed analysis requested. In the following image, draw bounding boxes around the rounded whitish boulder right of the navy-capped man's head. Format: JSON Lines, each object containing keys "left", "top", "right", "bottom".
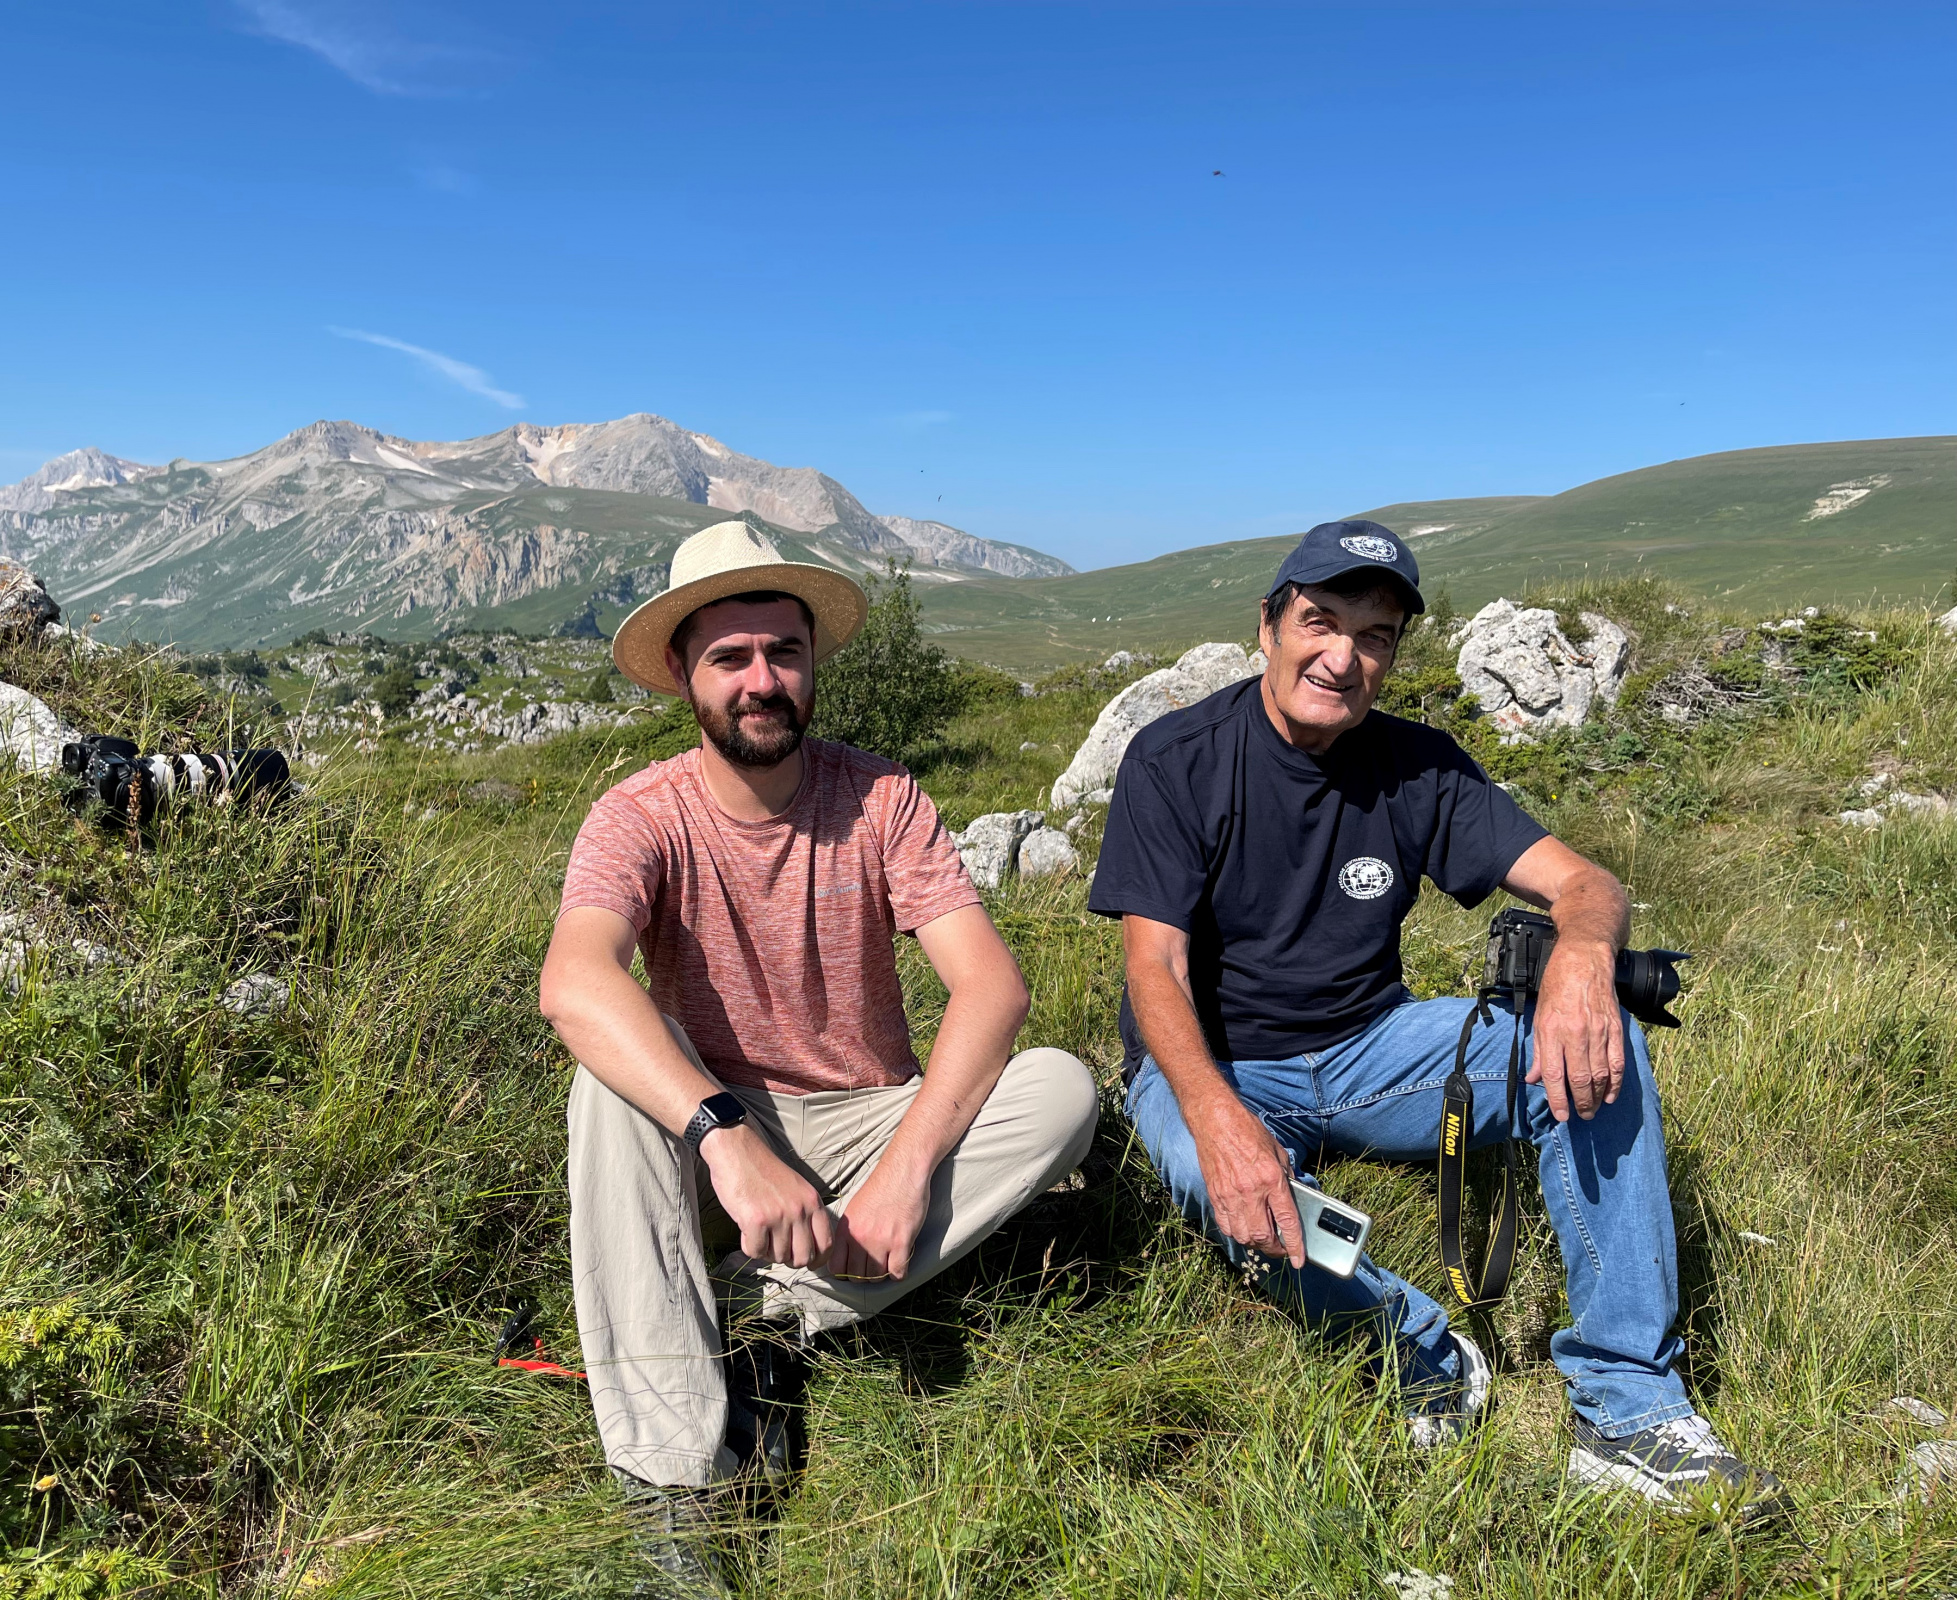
{"left": 1456, "top": 600, "right": 1630, "bottom": 741}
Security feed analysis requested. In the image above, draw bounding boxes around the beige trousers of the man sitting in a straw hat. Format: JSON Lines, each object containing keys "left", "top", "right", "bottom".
{"left": 569, "top": 1017, "right": 1096, "bottom": 1487}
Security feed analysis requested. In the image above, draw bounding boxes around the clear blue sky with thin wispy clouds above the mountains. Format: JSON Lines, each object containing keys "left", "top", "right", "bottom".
{"left": 0, "top": 0, "right": 1957, "bottom": 565}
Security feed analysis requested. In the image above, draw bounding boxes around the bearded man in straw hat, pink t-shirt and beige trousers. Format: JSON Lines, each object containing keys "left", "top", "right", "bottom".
{"left": 540, "top": 522, "right": 1096, "bottom": 1582}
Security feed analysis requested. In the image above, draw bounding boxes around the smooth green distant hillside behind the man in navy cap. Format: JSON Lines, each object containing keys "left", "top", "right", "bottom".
{"left": 924, "top": 438, "right": 1957, "bottom": 673}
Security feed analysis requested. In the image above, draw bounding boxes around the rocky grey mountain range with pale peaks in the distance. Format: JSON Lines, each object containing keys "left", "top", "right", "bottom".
{"left": 0, "top": 415, "right": 1067, "bottom": 645}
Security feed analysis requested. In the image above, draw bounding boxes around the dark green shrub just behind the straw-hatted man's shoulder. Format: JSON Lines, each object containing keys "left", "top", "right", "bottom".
{"left": 812, "top": 561, "right": 963, "bottom": 761}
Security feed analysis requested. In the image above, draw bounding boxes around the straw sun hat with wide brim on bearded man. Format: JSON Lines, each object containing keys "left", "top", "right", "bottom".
{"left": 613, "top": 522, "right": 869, "bottom": 694}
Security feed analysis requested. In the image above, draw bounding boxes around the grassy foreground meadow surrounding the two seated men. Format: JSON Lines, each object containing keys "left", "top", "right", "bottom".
{"left": 0, "top": 585, "right": 1957, "bottom": 1600}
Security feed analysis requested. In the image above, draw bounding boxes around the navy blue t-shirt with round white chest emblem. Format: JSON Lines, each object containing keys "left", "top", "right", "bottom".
{"left": 1088, "top": 679, "right": 1546, "bottom": 1078}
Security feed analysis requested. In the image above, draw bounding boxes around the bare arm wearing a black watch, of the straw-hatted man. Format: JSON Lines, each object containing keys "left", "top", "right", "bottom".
{"left": 538, "top": 906, "right": 834, "bottom": 1267}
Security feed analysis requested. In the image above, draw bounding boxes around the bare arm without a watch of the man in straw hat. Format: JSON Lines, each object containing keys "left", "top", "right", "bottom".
{"left": 834, "top": 906, "right": 1029, "bottom": 1279}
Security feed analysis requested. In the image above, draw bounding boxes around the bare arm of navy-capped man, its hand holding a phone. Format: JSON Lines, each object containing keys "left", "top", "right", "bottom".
{"left": 1121, "top": 915, "right": 1305, "bottom": 1267}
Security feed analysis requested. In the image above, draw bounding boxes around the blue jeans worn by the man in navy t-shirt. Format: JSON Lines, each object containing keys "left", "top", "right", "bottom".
{"left": 1127, "top": 1000, "right": 1693, "bottom": 1438}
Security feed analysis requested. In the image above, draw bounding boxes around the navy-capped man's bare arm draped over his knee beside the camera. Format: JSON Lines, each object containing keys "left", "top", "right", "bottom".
{"left": 1501, "top": 839, "right": 1630, "bottom": 1123}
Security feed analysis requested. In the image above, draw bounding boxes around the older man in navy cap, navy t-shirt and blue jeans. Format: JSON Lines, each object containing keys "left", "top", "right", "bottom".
{"left": 1088, "top": 522, "right": 1779, "bottom": 1520}
